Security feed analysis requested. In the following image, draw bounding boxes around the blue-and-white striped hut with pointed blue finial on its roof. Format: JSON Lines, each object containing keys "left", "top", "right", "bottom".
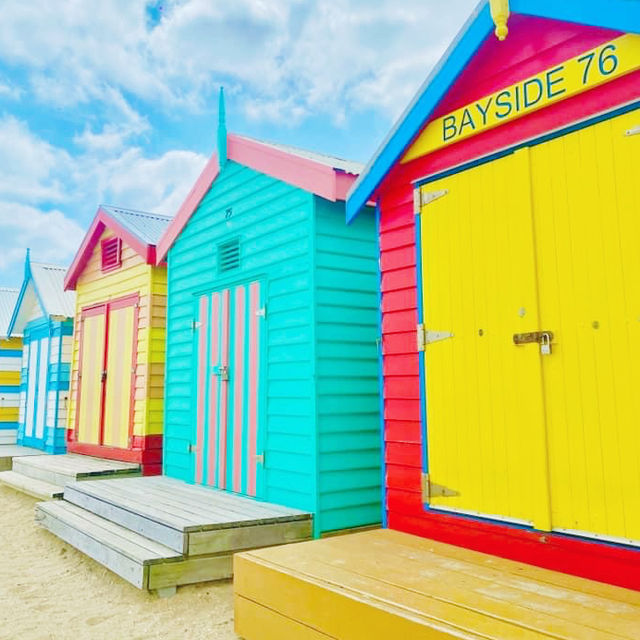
{"left": 8, "top": 251, "right": 75, "bottom": 453}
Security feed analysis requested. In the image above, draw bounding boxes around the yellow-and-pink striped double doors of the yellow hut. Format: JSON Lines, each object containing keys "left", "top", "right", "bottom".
{"left": 76, "top": 295, "right": 138, "bottom": 449}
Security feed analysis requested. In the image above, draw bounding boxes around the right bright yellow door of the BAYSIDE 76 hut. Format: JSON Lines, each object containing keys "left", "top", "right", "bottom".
{"left": 531, "top": 111, "right": 640, "bottom": 543}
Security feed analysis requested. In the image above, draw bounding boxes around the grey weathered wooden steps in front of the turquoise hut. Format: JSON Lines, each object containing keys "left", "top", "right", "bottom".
{"left": 36, "top": 476, "right": 312, "bottom": 595}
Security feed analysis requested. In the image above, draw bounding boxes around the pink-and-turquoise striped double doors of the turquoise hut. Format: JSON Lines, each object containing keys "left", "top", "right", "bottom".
{"left": 194, "top": 282, "right": 265, "bottom": 497}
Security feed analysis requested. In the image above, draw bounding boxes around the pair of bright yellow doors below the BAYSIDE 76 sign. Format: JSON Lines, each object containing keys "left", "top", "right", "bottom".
{"left": 420, "top": 110, "right": 640, "bottom": 545}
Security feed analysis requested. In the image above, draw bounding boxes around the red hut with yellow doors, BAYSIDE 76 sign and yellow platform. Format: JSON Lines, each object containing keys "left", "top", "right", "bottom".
{"left": 235, "top": 0, "right": 640, "bottom": 640}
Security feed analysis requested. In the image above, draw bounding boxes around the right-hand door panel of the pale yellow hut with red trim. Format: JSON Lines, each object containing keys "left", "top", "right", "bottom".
{"left": 102, "top": 302, "right": 137, "bottom": 449}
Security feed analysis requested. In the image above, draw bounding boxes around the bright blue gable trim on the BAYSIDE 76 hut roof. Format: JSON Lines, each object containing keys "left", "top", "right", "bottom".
{"left": 346, "top": 0, "right": 640, "bottom": 223}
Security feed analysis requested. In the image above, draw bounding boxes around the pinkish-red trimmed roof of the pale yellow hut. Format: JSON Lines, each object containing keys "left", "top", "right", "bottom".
{"left": 64, "top": 205, "right": 171, "bottom": 291}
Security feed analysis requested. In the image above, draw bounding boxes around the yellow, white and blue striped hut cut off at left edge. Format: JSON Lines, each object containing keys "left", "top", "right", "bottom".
{"left": 0, "top": 287, "right": 22, "bottom": 445}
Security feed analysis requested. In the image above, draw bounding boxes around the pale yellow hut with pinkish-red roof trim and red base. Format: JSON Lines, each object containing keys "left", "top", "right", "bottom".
{"left": 64, "top": 205, "right": 171, "bottom": 475}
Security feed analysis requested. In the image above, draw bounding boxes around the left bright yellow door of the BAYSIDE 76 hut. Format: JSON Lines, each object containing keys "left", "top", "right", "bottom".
{"left": 420, "top": 149, "right": 550, "bottom": 529}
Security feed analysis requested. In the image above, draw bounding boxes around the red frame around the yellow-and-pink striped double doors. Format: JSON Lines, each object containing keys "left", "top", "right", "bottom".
{"left": 71, "top": 292, "right": 140, "bottom": 452}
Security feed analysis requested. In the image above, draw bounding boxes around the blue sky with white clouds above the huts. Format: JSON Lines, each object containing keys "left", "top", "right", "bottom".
{"left": 0, "top": 0, "right": 477, "bottom": 287}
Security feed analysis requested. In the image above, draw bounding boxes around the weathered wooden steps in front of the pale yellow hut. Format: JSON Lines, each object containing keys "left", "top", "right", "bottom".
{"left": 0, "top": 447, "right": 140, "bottom": 499}
